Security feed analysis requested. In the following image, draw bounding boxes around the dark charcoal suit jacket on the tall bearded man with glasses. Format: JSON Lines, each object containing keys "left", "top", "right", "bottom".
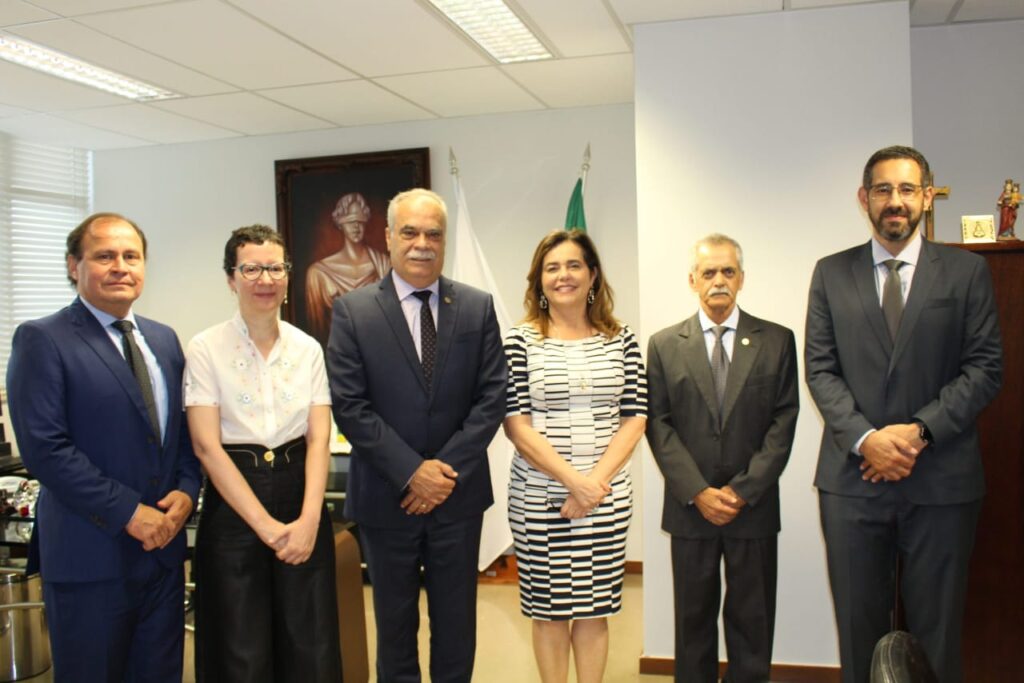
{"left": 804, "top": 237, "right": 1002, "bottom": 505}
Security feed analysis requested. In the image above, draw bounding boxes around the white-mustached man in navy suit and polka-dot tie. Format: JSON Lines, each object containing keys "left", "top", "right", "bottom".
{"left": 327, "top": 189, "right": 508, "bottom": 683}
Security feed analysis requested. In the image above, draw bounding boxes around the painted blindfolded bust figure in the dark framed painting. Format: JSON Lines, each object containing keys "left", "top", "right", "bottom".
{"left": 306, "top": 193, "right": 391, "bottom": 340}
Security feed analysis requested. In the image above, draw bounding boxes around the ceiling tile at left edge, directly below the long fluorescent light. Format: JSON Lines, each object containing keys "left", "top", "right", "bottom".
{"left": 0, "top": 61, "right": 125, "bottom": 112}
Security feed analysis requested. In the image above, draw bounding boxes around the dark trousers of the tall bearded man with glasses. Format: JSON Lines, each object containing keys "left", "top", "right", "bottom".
{"left": 818, "top": 483, "right": 981, "bottom": 683}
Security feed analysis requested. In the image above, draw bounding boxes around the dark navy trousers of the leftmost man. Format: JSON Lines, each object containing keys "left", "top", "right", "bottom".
{"left": 43, "top": 554, "right": 184, "bottom": 683}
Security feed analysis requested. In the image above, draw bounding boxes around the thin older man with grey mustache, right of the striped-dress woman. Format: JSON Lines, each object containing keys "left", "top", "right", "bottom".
{"left": 647, "top": 234, "right": 800, "bottom": 683}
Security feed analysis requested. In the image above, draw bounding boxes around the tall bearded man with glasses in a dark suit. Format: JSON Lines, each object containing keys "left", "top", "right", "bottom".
{"left": 805, "top": 146, "right": 1002, "bottom": 683}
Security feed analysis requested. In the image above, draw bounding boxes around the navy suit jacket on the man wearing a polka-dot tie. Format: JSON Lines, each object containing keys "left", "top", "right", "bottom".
{"left": 327, "top": 273, "right": 508, "bottom": 526}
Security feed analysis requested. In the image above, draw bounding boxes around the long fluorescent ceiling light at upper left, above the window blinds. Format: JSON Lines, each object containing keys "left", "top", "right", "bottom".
{"left": 0, "top": 34, "right": 180, "bottom": 101}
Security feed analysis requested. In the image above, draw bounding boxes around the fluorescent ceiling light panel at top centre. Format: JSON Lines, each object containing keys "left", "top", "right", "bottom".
{"left": 430, "top": 0, "right": 551, "bottom": 65}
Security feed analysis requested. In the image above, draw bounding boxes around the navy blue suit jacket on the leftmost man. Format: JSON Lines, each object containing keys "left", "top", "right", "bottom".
{"left": 7, "top": 299, "right": 201, "bottom": 582}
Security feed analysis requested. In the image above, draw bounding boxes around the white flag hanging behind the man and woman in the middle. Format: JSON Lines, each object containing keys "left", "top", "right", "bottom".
{"left": 450, "top": 150, "right": 513, "bottom": 571}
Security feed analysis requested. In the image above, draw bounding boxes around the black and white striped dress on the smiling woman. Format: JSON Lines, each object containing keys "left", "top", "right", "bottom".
{"left": 505, "top": 325, "right": 647, "bottom": 621}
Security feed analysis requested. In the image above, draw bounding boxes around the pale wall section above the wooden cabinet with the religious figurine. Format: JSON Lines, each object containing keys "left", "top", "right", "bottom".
{"left": 910, "top": 20, "right": 1024, "bottom": 242}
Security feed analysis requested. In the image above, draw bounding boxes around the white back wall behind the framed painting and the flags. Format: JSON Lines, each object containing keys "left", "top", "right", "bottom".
{"left": 95, "top": 105, "right": 642, "bottom": 560}
